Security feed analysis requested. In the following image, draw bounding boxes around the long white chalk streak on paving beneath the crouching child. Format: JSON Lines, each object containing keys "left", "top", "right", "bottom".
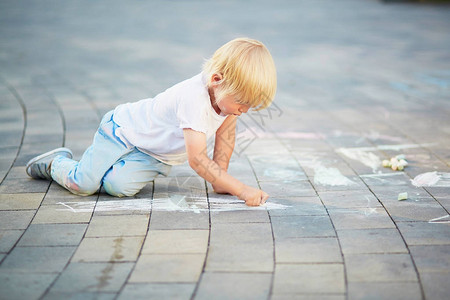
{"left": 57, "top": 195, "right": 290, "bottom": 213}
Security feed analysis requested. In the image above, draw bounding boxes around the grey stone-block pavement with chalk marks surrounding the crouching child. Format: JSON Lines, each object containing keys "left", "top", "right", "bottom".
{"left": 0, "top": 0, "right": 450, "bottom": 300}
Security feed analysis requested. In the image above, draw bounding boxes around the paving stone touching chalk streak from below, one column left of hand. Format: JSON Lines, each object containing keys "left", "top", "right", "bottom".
{"left": 150, "top": 211, "right": 209, "bottom": 230}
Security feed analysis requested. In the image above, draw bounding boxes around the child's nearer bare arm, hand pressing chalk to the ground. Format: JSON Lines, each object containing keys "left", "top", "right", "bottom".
{"left": 183, "top": 129, "right": 269, "bottom": 206}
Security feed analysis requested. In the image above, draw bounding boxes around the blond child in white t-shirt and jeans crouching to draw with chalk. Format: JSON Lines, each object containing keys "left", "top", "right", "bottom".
{"left": 26, "top": 38, "right": 276, "bottom": 206}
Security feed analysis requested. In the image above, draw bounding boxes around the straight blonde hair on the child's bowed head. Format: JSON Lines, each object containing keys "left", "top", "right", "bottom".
{"left": 203, "top": 38, "right": 277, "bottom": 110}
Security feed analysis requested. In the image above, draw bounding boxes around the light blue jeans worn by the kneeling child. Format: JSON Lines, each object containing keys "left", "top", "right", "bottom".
{"left": 51, "top": 111, "right": 171, "bottom": 197}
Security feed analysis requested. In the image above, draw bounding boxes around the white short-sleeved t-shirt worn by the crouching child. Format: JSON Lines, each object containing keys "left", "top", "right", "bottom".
{"left": 113, "top": 73, "right": 226, "bottom": 165}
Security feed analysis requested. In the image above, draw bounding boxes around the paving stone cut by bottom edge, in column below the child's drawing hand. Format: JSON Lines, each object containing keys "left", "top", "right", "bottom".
{"left": 195, "top": 272, "right": 272, "bottom": 300}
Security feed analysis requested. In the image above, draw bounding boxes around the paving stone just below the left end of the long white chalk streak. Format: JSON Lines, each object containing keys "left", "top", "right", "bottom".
{"left": 32, "top": 205, "right": 93, "bottom": 224}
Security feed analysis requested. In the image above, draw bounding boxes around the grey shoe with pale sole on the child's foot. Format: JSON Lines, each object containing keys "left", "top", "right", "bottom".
{"left": 26, "top": 148, "right": 73, "bottom": 180}
